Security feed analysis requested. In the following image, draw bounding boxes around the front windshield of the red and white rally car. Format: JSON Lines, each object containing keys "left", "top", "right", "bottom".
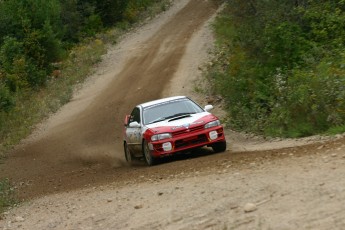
{"left": 143, "top": 98, "right": 204, "bottom": 125}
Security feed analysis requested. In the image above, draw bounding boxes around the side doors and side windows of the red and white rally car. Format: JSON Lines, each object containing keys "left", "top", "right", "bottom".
{"left": 126, "top": 107, "right": 142, "bottom": 155}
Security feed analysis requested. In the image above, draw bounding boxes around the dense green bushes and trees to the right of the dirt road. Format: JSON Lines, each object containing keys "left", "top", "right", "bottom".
{"left": 209, "top": 0, "right": 345, "bottom": 137}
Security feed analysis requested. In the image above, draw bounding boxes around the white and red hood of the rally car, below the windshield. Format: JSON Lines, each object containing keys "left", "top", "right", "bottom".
{"left": 146, "top": 112, "right": 218, "bottom": 133}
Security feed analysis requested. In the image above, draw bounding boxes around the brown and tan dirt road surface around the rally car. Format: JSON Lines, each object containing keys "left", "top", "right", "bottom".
{"left": 0, "top": 0, "right": 345, "bottom": 229}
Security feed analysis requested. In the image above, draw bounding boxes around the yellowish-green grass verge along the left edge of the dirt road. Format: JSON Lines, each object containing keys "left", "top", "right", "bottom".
{"left": 0, "top": 0, "right": 170, "bottom": 214}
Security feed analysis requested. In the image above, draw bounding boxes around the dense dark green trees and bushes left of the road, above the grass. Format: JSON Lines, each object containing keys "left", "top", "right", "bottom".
{"left": 0, "top": 0, "right": 167, "bottom": 95}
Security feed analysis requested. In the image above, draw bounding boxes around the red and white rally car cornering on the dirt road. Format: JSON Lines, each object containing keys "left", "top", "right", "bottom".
{"left": 124, "top": 96, "right": 226, "bottom": 165}
